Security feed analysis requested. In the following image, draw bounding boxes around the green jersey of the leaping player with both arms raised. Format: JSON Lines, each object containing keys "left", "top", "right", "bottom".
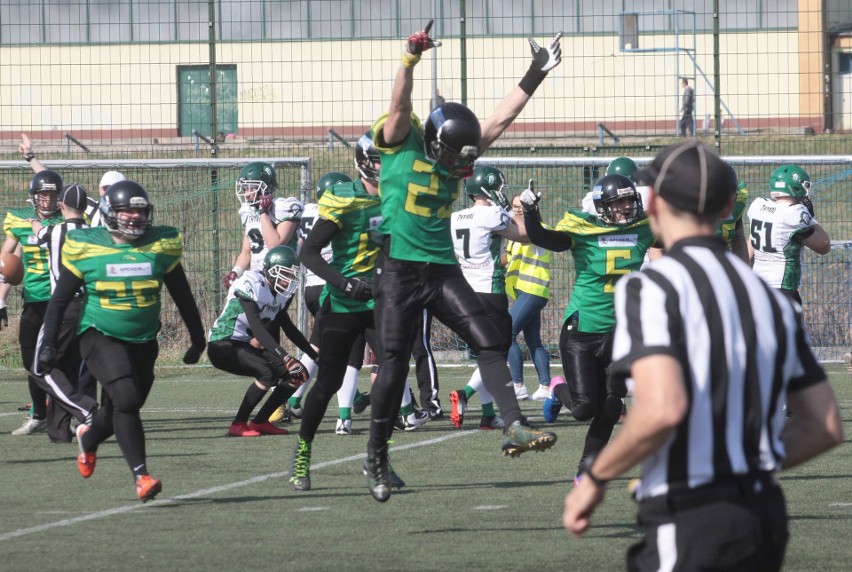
{"left": 372, "top": 113, "right": 459, "bottom": 265}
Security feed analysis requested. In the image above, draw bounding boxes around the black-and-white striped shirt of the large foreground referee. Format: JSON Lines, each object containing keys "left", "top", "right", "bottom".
{"left": 612, "top": 237, "right": 825, "bottom": 499}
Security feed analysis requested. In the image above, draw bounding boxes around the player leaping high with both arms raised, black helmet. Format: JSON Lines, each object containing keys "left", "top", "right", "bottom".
{"left": 365, "top": 22, "right": 562, "bottom": 502}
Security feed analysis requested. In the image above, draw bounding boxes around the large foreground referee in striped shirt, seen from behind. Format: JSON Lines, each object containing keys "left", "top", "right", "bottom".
{"left": 563, "top": 141, "right": 843, "bottom": 571}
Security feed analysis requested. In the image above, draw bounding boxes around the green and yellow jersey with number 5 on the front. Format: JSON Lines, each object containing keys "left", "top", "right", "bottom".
{"left": 556, "top": 209, "right": 655, "bottom": 334}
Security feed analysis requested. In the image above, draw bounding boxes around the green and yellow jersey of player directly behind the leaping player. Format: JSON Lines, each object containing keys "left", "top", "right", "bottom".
{"left": 319, "top": 180, "right": 382, "bottom": 314}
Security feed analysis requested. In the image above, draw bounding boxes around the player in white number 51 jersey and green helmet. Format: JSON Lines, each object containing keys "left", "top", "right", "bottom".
{"left": 748, "top": 165, "right": 831, "bottom": 304}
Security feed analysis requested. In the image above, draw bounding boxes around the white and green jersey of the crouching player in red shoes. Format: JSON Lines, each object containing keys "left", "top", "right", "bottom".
{"left": 208, "top": 270, "right": 292, "bottom": 342}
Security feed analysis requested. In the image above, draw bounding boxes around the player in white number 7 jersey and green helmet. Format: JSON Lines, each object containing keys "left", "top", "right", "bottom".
{"left": 450, "top": 167, "right": 529, "bottom": 429}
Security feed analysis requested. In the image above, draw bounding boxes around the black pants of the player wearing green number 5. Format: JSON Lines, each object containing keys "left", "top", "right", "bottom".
{"left": 555, "top": 316, "right": 627, "bottom": 468}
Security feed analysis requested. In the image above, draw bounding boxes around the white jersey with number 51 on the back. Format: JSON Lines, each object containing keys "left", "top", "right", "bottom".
{"left": 748, "top": 197, "right": 817, "bottom": 291}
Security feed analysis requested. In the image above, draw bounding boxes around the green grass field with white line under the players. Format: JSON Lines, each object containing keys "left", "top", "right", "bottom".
{"left": 0, "top": 365, "right": 852, "bottom": 572}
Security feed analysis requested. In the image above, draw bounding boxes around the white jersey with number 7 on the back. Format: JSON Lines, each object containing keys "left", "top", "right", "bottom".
{"left": 450, "top": 205, "right": 512, "bottom": 294}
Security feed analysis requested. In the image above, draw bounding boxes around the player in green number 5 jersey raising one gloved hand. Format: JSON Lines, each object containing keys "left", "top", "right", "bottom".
{"left": 520, "top": 175, "right": 656, "bottom": 485}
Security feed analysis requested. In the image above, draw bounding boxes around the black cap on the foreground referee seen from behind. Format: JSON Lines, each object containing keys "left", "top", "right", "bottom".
{"left": 637, "top": 141, "right": 737, "bottom": 215}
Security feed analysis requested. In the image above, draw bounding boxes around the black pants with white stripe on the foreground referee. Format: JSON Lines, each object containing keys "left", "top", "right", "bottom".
{"left": 627, "top": 476, "right": 789, "bottom": 572}
